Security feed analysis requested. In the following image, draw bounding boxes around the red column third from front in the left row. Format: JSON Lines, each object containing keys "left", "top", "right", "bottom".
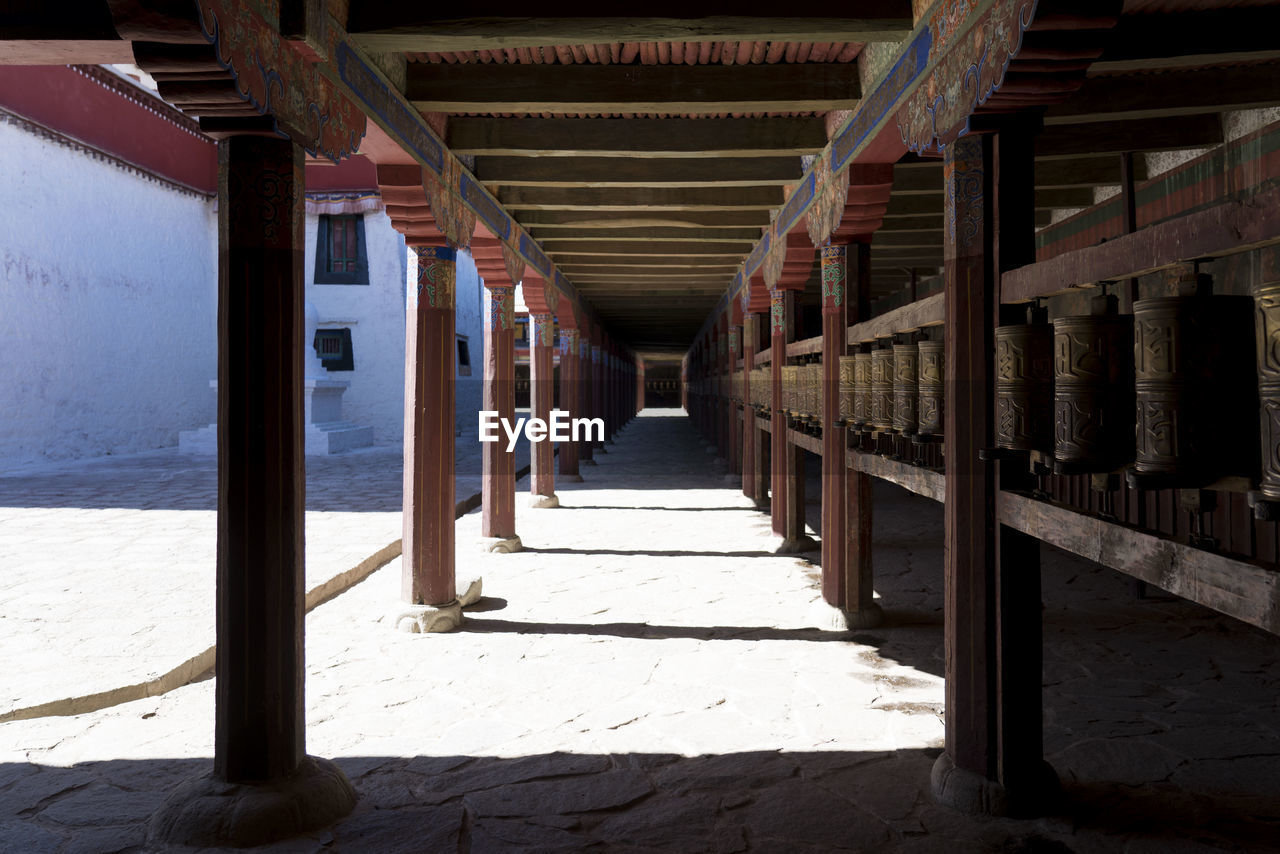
{"left": 480, "top": 282, "right": 520, "bottom": 552}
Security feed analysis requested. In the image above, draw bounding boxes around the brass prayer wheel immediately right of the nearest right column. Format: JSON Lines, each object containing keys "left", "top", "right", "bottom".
{"left": 996, "top": 323, "right": 1053, "bottom": 452}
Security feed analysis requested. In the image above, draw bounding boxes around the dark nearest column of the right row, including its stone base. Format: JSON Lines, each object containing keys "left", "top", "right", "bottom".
{"left": 933, "top": 128, "right": 1057, "bottom": 814}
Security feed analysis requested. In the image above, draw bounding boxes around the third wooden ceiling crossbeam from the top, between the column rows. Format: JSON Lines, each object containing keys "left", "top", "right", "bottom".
{"left": 448, "top": 117, "right": 827, "bottom": 157}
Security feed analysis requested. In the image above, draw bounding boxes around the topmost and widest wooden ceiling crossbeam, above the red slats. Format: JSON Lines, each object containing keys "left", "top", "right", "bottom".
{"left": 346, "top": 8, "right": 914, "bottom": 52}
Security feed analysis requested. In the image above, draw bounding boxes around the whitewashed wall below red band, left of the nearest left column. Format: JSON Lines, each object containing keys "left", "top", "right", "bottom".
{"left": 0, "top": 122, "right": 218, "bottom": 469}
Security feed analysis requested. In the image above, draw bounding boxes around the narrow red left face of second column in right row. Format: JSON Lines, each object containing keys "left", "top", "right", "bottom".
{"left": 822, "top": 243, "right": 849, "bottom": 608}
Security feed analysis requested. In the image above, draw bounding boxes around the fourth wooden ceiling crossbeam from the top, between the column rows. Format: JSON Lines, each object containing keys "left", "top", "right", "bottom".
{"left": 475, "top": 156, "right": 804, "bottom": 187}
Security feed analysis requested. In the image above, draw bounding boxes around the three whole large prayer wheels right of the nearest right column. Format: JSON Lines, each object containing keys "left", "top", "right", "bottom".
{"left": 995, "top": 274, "right": 1254, "bottom": 486}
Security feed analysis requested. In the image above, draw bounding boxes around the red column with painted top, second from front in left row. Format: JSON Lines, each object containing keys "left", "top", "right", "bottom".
{"left": 401, "top": 246, "right": 457, "bottom": 612}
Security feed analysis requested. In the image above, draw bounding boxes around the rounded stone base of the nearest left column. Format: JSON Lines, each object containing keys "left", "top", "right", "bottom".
{"left": 147, "top": 757, "right": 356, "bottom": 848}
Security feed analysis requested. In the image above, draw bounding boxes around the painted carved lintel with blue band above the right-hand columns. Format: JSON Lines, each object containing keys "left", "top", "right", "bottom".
{"left": 703, "top": 0, "right": 1037, "bottom": 348}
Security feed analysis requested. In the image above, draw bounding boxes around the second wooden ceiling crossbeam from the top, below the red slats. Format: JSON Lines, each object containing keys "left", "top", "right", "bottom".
{"left": 404, "top": 61, "right": 861, "bottom": 113}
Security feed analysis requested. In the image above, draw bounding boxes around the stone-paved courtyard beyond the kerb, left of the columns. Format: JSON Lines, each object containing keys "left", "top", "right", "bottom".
{"left": 0, "top": 438, "right": 529, "bottom": 716}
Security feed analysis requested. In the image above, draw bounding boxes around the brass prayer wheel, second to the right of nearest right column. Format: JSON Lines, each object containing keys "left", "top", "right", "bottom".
{"left": 1053, "top": 296, "right": 1134, "bottom": 474}
